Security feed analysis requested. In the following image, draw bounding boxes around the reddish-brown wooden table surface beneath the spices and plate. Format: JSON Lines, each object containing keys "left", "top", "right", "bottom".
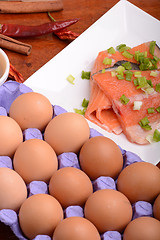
{"left": 0, "top": 0, "right": 160, "bottom": 240}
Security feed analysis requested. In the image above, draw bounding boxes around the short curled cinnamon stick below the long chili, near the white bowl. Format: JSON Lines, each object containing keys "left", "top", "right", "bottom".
{"left": 0, "top": 34, "right": 32, "bottom": 55}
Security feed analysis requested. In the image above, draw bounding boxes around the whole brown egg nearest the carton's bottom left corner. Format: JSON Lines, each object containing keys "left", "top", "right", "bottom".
{"left": 19, "top": 194, "right": 63, "bottom": 239}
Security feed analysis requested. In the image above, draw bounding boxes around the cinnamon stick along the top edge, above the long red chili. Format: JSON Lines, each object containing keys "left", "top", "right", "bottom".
{"left": 0, "top": 0, "right": 63, "bottom": 13}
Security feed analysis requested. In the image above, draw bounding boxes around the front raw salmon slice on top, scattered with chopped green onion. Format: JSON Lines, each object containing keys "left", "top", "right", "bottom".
{"left": 92, "top": 70, "right": 160, "bottom": 144}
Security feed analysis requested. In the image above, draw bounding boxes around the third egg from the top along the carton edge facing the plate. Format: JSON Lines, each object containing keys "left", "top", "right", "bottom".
{"left": 79, "top": 136, "right": 123, "bottom": 180}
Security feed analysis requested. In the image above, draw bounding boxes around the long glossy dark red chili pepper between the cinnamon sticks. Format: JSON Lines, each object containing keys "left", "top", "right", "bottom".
{"left": 0, "top": 18, "right": 79, "bottom": 37}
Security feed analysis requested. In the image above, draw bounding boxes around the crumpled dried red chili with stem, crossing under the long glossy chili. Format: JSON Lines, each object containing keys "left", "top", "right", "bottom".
{"left": 48, "top": 13, "right": 80, "bottom": 40}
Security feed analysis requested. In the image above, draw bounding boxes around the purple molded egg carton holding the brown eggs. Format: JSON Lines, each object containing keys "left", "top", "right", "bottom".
{"left": 0, "top": 81, "right": 153, "bottom": 240}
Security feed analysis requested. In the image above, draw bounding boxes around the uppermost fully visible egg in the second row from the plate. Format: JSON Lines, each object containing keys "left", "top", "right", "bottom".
{"left": 13, "top": 139, "right": 58, "bottom": 183}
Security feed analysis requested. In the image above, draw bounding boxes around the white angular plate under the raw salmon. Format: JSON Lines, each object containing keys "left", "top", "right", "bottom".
{"left": 25, "top": 0, "right": 160, "bottom": 164}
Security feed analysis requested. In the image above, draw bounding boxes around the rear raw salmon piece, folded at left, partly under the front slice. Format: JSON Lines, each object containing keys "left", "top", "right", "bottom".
{"left": 85, "top": 42, "right": 160, "bottom": 143}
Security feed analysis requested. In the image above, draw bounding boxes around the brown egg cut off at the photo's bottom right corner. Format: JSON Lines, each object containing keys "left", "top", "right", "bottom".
{"left": 123, "top": 217, "right": 160, "bottom": 240}
